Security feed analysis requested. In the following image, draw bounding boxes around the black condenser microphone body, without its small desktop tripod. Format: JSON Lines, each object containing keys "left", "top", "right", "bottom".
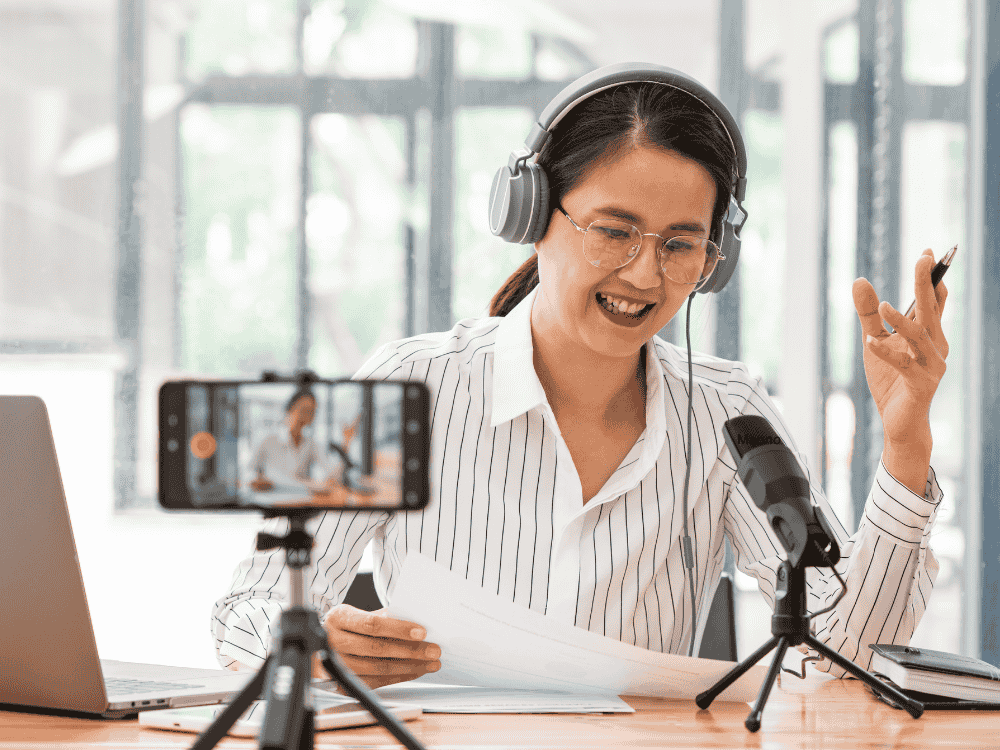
{"left": 722, "top": 415, "right": 840, "bottom": 567}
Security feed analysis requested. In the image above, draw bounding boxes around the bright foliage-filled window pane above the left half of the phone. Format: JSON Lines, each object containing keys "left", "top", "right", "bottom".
{"left": 180, "top": 105, "right": 299, "bottom": 377}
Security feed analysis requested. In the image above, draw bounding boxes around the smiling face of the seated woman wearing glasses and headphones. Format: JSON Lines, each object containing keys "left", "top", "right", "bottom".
{"left": 532, "top": 147, "right": 715, "bottom": 357}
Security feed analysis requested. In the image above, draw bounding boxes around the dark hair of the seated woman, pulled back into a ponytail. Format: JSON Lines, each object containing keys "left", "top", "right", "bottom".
{"left": 490, "top": 83, "right": 736, "bottom": 317}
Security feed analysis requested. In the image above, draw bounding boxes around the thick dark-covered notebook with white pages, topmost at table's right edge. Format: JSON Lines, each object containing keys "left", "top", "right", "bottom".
{"left": 870, "top": 644, "right": 1000, "bottom": 703}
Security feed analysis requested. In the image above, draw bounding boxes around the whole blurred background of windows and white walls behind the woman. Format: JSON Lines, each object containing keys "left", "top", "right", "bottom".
{"left": 0, "top": 0, "right": 1000, "bottom": 666}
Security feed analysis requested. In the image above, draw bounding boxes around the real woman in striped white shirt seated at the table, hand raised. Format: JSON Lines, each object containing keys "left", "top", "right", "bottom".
{"left": 213, "top": 72, "right": 947, "bottom": 686}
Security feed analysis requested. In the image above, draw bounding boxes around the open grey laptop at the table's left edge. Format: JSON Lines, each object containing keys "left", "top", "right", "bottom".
{"left": 0, "top": 396, "right": 253, "bottom": 718}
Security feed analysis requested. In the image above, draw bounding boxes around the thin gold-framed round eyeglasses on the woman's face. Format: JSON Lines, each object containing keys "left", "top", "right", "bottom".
{"left": 556, "top": 206, "right": 726, "bottom": 289}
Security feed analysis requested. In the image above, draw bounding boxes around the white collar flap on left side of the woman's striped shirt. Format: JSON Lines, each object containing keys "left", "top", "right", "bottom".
{"left": 490, "top": 286, "right": 546, "bottom": 427}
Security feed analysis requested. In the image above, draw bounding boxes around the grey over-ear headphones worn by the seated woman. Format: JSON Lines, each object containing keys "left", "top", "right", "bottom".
{"left": 490, "top": 63, "right": 747, "bottom": 293}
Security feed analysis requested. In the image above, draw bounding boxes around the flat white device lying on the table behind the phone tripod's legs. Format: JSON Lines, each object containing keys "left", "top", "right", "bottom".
{"left": 139, "top": 696, "right": 423, "bottom": 737}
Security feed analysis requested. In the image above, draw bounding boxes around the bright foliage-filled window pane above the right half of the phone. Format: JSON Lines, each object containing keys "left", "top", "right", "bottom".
{"left": 306, "top": 114, "right": 408, "bottom": 376}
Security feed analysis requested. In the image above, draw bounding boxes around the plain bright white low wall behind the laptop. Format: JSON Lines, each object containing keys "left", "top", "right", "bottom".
{"left": 0, "top": 362, "right": 260, "bottom": 667}
